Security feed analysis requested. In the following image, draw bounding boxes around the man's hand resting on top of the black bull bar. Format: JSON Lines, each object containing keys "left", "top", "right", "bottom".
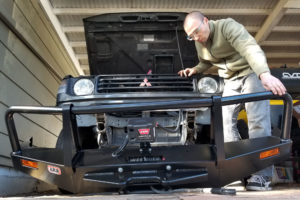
{"left": 259, "top": 72, "right": 286, "bottom": 96}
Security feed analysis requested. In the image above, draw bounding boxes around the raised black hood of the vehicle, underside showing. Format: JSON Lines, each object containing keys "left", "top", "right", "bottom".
{"left": 83, "top": 13, "right": 198, "bottom": 75}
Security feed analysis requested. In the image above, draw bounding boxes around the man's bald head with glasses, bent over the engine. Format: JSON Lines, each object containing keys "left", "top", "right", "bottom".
{"left": 183, "top": 11, "right": 210, "bottom": 43}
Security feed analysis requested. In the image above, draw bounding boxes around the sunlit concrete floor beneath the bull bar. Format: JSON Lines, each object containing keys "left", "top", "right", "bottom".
{"left": 0, "top": 184, "right": 300, "bottom": 200}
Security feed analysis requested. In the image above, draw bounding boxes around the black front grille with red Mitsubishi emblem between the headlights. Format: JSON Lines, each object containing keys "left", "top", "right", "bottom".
{"left": 97, "top": 74, "right": 194, "bottom": 93}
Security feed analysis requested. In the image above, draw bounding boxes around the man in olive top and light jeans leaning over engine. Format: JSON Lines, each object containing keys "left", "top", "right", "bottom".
{"left": 178, "top": 11, "right": 286, "bottom": 190}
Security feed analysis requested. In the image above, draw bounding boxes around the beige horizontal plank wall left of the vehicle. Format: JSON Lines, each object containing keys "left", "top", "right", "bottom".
{"left": 0, "top": 0, "right": 79, "bottom": 195}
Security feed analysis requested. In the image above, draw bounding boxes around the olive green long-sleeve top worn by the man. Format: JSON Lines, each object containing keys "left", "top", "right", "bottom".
{"left": 195, "top": 18, "right": 270, "bottom": 79}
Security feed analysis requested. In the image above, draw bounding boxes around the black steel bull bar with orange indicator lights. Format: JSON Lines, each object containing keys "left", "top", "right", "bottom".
{"left": 5, "top": 92, "right": 293, "bottom": 192}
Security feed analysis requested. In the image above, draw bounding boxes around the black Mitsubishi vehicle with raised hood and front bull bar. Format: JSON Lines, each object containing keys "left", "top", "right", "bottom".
{"left": 6, "top": 13, "right": 292, "bottom": 193}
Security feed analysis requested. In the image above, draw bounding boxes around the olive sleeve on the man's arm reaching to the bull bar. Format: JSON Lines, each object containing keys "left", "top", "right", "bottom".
{"left": 222, "top": 19, "right": 270, "bottom": 77}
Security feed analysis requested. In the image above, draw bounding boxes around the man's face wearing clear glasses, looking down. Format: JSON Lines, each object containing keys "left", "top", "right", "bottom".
{"left": 184, "top": 18, "right": 210, "bottom": 43}
